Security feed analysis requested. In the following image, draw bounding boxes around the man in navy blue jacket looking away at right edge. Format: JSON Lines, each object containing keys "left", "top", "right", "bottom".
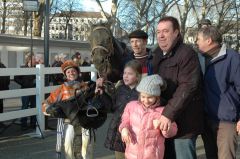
{"left": 197, "top": 26, "right": 240, "bottom": 159}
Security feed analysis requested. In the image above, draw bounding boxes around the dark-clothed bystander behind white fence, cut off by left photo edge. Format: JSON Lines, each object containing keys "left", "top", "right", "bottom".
{"left": 0, "top": 60, "right": 10, "bottom": 113}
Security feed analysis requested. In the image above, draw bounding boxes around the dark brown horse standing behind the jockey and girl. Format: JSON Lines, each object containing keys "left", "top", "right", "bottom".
{"left": 89, "top": 23, "right": 134, "bottom": 83}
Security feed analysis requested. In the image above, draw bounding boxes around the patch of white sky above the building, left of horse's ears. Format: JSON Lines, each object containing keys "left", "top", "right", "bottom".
{"left": 80, "top": 0, "right": 111, "bottom": 13}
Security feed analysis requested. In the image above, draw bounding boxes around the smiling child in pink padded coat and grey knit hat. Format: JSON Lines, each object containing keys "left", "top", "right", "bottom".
{"left": 119, "top": 74, "right": 177, "bottom": 159}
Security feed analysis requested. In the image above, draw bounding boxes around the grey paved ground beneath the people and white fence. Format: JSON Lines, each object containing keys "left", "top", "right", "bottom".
{"left": 0, "top": 99, "right": 240, "bottom": 159}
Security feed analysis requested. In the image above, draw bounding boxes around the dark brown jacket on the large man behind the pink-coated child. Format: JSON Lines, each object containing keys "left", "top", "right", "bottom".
{"left": 153, "top": 39, "right": 203, "bottom": 138}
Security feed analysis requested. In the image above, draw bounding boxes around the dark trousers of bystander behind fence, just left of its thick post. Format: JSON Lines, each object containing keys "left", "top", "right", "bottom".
{"left": 21, "top": 96, "right": 36, "bottom": 126}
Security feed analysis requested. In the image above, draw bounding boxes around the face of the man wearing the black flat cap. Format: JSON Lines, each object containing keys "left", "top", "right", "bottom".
{"left": 130, "top": 38, "right": 147, "bottom": 55}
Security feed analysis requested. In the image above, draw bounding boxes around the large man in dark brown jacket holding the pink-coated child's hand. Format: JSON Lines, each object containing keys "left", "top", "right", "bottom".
{"left": 152, "top": 17, "right": 203, "bottom": 159}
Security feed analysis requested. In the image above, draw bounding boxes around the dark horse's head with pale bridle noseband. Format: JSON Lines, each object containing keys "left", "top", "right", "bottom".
{"left": 89, "top": 23, "right": 114, "bottom": 78}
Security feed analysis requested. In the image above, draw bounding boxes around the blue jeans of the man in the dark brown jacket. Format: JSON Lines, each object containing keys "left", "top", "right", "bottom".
{"left": 174, "top": 136, "right": 197, "bottom": 159}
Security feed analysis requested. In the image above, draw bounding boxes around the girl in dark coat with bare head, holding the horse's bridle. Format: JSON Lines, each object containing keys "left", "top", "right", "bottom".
{"left": 96, "top": 60, "right": 142, "bottom": 159}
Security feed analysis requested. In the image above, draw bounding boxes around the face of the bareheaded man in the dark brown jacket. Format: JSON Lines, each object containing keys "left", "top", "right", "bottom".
{"left": 157, "top": 21, "right": 179, "bottom": 52}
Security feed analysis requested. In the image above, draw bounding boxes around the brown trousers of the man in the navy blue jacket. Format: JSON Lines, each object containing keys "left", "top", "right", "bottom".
{"left": 202, "top": 119, "right": 237, "bottom": 159}
